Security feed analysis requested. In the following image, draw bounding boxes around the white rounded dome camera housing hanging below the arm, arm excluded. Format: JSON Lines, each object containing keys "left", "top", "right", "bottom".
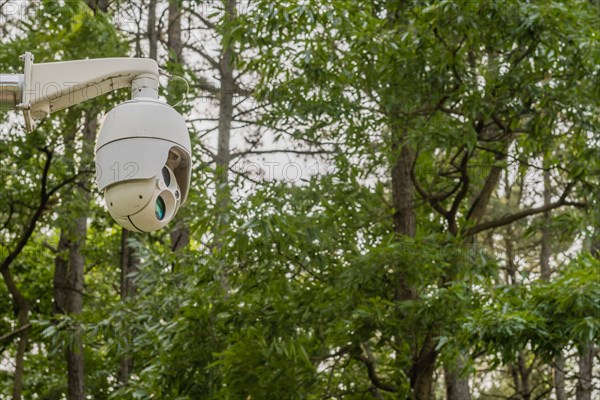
{"left": 96, "top": 97, "right": 192, "bottom": 232}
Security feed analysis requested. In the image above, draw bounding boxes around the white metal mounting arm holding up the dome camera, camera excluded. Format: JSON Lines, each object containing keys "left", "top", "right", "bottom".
{"left": 0, "top": 52, "right": 159, "bottom": 131}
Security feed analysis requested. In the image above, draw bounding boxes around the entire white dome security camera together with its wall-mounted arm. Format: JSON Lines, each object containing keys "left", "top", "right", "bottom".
{"left": 0, "top": 52, "right": 192, "bottom": 232}
